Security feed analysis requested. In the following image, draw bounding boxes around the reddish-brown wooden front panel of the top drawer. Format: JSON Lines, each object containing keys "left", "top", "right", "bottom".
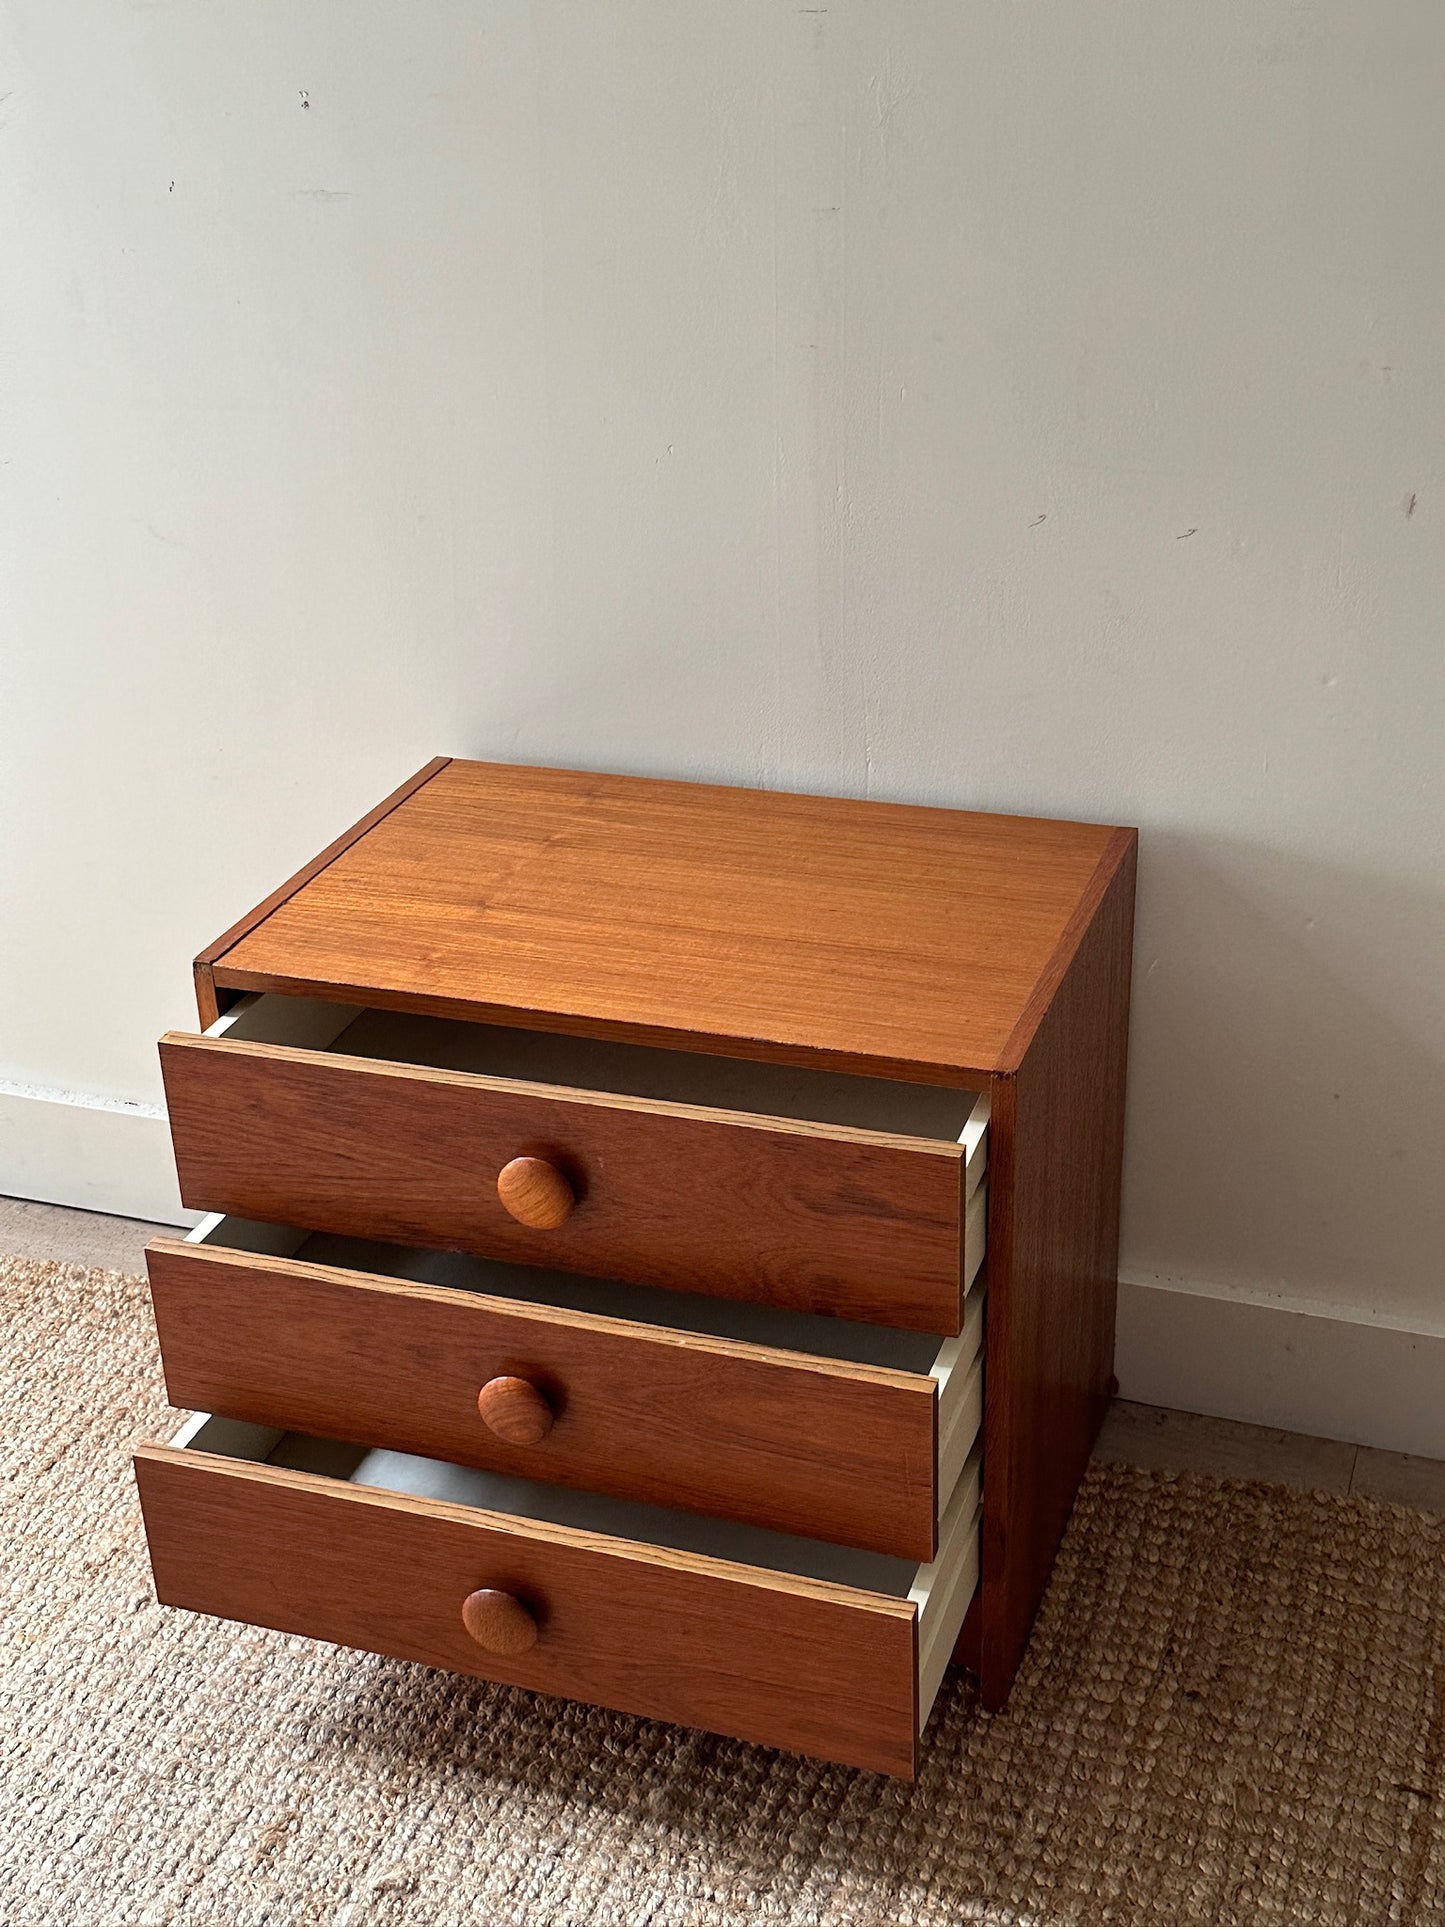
{"left": 162, "top": 1033, "right": 981, "bottom": 1333}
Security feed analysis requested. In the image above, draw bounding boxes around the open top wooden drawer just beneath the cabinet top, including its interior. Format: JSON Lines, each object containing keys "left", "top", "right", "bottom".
{"left": 160, "top": 996, "right": 988, "bottom": 1333}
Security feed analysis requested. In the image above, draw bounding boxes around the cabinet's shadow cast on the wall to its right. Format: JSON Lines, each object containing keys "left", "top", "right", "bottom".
{"left": 1121, "top": 832, "right": 1445, "bottom": 1330}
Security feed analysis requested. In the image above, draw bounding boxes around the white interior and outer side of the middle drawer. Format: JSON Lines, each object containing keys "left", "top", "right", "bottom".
{"left": 187, "top": 1210, "right": 986, "bottom": 1497}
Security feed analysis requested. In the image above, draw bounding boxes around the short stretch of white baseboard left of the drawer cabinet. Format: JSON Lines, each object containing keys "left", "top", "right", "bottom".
{"left": 0, "top": 1083, "right": 197, "bottom": 1224}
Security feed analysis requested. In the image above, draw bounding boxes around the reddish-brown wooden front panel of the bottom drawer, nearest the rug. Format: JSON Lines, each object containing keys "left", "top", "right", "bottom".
{"left": 135, "top": 1447, "right": 919, "bottom": 1775}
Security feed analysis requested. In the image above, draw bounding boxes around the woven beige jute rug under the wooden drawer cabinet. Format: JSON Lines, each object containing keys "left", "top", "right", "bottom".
{"left": 0, "top": 1262, "right": 1445, "bottom": 1927}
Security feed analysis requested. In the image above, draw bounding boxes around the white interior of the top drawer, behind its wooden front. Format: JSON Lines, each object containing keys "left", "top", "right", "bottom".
{"left": 206, "top": 994, "right": 988, "bottom": 1191}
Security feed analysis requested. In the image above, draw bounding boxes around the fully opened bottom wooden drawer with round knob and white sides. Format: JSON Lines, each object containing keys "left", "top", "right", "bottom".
{"left": 135, "top": 1416, "right": 979, "bottom": 1777}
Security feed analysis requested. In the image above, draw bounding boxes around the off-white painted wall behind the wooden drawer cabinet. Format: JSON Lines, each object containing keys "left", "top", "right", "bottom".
{"left": 0, "top": 0, "right": 1445, "bottom": 1425}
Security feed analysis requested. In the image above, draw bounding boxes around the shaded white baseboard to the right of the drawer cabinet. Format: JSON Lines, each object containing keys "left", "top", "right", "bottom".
{"left": 1116, "top": 1280, "right": 1445, "bottom": 1459}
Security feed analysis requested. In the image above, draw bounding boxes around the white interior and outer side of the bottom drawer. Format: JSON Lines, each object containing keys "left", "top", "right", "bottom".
{"left": 171, "top": 1412, "right": 981, "bottom": 1721}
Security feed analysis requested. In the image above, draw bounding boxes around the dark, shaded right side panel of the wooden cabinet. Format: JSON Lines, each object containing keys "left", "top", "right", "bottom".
{"left": 979, "top": 842, "right": 1137, "bottom": 1709}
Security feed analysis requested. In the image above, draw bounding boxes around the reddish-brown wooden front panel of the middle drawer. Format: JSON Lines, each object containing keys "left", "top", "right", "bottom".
{"left": 146, "top": 1239, "right": 951, "bottom": 1559}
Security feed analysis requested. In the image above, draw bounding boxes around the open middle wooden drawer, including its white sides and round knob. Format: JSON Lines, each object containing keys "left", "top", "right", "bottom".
{"left": 146, "top": 1217, "right": 983, "bottom": 1559}
